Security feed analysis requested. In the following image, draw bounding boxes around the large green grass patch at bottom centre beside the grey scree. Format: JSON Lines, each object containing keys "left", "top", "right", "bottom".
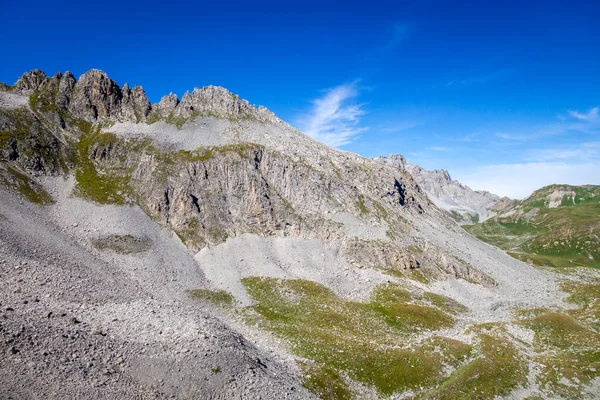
{"left": 242, "top": 277, "right": 469, "bottom": 395}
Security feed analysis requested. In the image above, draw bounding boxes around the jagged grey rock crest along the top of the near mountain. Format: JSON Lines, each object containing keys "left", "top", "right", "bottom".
{"left": 12, "top": 69, "right": 280, "bottom": 124}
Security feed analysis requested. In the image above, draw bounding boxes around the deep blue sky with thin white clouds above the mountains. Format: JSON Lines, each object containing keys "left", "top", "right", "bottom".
{"left": 0, "top": 1, "right": 600, "bottom": 197}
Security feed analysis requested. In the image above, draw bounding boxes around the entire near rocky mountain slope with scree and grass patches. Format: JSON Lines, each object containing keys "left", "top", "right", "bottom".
{"left": 0, "top": 70, "right": 600, "bottom": 399}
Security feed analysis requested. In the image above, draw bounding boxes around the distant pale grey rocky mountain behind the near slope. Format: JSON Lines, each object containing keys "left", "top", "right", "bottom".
{"left": 375, "top": 154, "right": 500, "bottom": 225}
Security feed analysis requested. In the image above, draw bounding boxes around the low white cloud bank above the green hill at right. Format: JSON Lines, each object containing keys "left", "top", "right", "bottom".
{"left": 453, "top": 161, "right": 600, "bottom": 199}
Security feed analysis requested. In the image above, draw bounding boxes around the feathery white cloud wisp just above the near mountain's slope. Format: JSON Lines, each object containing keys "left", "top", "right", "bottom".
{"left": 297, "top": 82, "right": 366, "bottom": 147}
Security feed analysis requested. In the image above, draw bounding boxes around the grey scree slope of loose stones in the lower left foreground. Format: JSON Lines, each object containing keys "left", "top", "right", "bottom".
{"left": 0, "top": 186, "right": 311, "bottom": 399}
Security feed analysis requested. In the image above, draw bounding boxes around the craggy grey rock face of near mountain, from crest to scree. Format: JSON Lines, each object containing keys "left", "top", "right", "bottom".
{"left": 0, "top": 70, "right": 491, "bottom": 283}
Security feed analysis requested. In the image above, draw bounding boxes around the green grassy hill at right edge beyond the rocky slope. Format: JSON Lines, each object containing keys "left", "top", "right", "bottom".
{"left": 465, "top": 185, "right": 600, "bottom": 268}
